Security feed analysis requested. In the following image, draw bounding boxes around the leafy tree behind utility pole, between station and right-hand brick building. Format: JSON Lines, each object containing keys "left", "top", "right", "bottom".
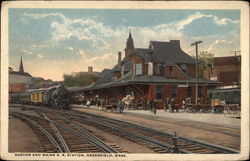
{"left": 193, "top": 51, "right": 214, "bottom": 77}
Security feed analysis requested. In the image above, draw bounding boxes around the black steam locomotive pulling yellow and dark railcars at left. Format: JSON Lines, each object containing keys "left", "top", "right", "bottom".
{"left": 10, "top": 85, "right": 70, "bottom": 109}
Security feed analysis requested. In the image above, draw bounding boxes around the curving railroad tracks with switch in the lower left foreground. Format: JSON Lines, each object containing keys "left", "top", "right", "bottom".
{"left": 10, "top": 112, "right": 118, "bottom": 153}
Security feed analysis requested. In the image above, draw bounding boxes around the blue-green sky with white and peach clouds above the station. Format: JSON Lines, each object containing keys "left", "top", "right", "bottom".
{"left": 9, "top": 8, "right": 240, "bottom": 81}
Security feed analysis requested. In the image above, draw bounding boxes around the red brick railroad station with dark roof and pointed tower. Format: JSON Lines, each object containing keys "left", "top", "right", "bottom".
{"left": 71, "top": 32, "right": 221, "bottom": 108}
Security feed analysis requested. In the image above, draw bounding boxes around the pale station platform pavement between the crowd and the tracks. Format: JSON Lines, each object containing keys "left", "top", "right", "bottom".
{"left": 72, "top": 105, "right": 241, "bottom": 129}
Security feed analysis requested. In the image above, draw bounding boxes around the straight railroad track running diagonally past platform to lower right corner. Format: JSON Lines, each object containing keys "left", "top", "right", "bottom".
{"left": 9, "top": 104, "right": 239, "bottom": 154}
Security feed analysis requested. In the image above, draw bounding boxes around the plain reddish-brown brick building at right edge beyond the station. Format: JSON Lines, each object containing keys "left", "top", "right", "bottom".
{"left": 203, "top": 56, "right": 241, "bottom": 86}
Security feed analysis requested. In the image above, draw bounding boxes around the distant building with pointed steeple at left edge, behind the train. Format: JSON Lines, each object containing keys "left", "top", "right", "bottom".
{"left": 9, "top": 57, "right": 32, "bottom": 93}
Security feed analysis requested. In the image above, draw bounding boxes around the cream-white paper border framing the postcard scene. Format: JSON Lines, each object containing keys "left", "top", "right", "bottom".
{"left": 0, "top": 1, "right": 249, "bottom": 160}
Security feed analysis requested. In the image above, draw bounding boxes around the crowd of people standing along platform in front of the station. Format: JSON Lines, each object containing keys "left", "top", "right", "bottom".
{"left": 74, "top": 94, "right": 211, "bottom": 114}
